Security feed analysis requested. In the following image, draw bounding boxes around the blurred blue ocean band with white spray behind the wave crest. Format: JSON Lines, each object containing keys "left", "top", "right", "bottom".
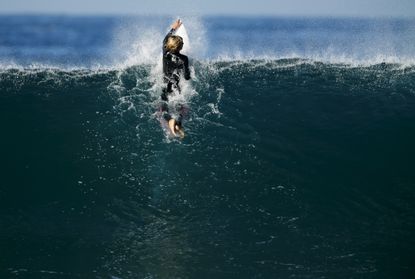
{"left": 0, "top": 16, "right": 415, "bottom": 70}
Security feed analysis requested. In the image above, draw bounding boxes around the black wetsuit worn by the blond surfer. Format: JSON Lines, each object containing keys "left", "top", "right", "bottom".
{"left": 161, "top": 29, "right": 190, "bottom": 125}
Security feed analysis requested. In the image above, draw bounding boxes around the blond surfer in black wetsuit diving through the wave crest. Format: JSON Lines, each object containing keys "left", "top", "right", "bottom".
{"left": 161, "top": 19, "right": 190, "bottom": 138}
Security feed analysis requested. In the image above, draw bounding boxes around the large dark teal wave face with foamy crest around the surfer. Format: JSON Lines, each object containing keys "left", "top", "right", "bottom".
{"left": 0, "top": 59, "right": 415, "bottom": 278}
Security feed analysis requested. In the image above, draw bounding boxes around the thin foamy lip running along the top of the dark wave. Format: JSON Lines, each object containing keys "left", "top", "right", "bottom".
{"left": 0, "top": 58, "right": 415, "bottom": 90}
